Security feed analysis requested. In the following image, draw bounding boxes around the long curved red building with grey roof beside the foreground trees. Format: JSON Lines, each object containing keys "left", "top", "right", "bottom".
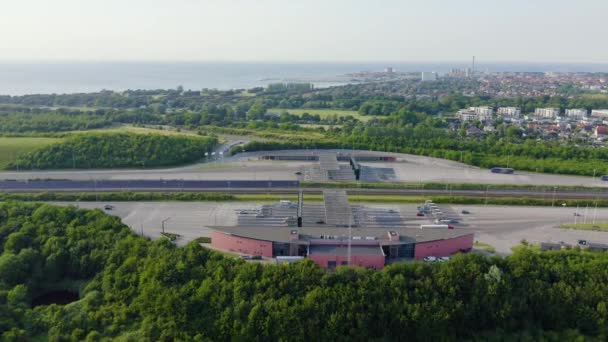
{"left": 211, "top": 227, "right": 474, "bottom": 269}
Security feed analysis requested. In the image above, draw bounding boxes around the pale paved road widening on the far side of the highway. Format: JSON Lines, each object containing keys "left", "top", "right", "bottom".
{"left": 0, "top": 150, "right": 608, "bottom": 187}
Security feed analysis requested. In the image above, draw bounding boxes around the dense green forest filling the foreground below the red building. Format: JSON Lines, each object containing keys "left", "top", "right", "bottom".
{"left": 0, "top": 202, "right": 608, "bottom": 341}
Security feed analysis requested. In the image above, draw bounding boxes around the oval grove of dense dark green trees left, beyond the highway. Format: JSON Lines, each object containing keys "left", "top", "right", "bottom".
{"left": 9, "top": 133, "right": 217, "bottom": 169}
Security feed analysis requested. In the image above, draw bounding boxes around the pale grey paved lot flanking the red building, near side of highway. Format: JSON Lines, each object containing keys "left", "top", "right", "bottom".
{"left": 62, "top": 202, "right": 608, "bottom": 254}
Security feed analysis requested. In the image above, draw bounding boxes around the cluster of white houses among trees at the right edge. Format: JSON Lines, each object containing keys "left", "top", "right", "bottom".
{"left": 448, "top": 106, "right": 608, "bottom": 142}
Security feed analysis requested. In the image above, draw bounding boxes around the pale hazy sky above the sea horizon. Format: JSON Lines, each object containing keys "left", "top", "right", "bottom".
{"left": 0, "top": 0, "right": 608, "bottom": 63}
